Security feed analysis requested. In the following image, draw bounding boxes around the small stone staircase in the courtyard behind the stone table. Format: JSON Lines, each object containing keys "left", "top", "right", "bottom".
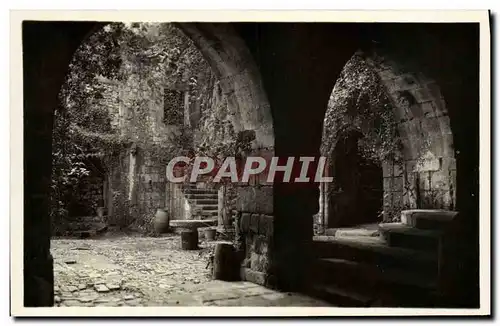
{"left": 182, "top": 183, "right": 219, "bottom": 220}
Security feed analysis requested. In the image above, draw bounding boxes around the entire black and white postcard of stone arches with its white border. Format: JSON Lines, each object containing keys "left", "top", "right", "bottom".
{"left": 10, "top": 10, "right": 491, "bottom": 316}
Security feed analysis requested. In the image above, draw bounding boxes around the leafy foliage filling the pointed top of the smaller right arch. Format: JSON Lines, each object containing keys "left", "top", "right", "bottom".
{"left": 321, "top": 53, "right": 401, "bottom": 166}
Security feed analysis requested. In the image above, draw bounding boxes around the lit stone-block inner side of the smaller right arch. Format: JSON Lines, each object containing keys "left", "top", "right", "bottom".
{"left": 371, "top": 56, "right": 456, "bottom": 210}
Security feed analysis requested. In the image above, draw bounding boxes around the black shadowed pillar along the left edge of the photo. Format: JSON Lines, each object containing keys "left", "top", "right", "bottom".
{"left": 19, "top": 21, "right": 87, "bottom": 307}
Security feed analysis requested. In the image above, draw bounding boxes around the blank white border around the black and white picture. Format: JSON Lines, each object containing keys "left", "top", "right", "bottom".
{"left": 10, "top": 10, "right": 491, "bottom": 317}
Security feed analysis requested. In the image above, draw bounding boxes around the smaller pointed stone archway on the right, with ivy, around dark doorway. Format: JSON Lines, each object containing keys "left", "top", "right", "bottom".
{"left": 320, "top": 49, "right": 456, "bottom": 232}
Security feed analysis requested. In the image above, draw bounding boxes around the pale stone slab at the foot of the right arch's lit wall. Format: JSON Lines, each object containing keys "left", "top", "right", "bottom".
{"left": 401, "top": 209, "right": 458, "bottom": 230}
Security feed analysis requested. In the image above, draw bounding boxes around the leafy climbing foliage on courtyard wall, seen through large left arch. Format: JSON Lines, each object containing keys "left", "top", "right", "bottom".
{"left": 51, "top": 23, "right": 210, "bottom": 229}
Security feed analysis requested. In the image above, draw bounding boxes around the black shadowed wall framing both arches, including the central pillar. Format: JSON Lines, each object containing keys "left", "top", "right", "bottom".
{"left": 23, "top": 21, "right": 479, "bottom": 307}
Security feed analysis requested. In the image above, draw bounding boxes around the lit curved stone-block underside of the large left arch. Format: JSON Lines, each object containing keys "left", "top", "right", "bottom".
{"left": 176, "top": 23, "right": 274, "bottom": 148}
